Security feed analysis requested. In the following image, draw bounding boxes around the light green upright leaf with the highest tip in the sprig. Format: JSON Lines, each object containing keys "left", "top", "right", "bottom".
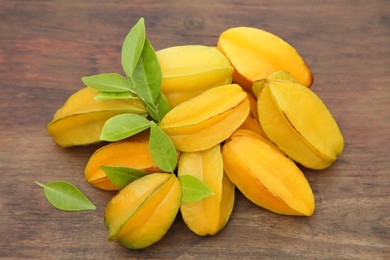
{"left": 122, "top": 18, "right": 146, "bottom": 77}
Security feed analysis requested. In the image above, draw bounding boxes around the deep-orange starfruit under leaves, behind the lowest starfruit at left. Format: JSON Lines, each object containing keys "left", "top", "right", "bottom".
{"left": 84, "top": 133, "right": 163, "bottom": 190}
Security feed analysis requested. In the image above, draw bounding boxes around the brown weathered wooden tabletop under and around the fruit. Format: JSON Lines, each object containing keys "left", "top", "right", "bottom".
{"left": 0, "top": 0, "right": 390, "bottom": 259}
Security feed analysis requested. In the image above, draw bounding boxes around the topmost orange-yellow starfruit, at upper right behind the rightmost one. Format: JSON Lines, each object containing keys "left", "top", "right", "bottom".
{"left": 217, "top": 27, "right": 313, "bottom": 91}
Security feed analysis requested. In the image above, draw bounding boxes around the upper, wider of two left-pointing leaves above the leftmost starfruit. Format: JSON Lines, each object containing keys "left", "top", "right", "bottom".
{"left": 81, "top": 73, "right": 130, "bottom": 92}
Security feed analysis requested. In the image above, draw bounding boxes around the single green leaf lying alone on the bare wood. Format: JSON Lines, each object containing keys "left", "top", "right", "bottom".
{"left": 35, "top": 181, "right": 96, "bottom": 211}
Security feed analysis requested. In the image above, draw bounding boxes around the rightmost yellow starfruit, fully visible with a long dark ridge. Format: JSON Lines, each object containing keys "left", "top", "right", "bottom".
{"left": 258, "top": 80, "right": 344, "bottom": 169}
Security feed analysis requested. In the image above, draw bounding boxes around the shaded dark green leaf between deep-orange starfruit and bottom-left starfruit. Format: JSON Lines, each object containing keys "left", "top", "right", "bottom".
{"left": 100, "top": 166, "right": 149, "bottom": 188}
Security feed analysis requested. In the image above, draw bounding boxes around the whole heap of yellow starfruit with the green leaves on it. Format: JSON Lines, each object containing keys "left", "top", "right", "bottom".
{"left": 48, "top": 18, "right": 344, "bottom": 248}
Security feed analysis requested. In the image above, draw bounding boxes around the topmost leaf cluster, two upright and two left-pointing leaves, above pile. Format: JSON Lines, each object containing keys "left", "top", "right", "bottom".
{"left": 81, "top": 18, "right": 169, "bottom": 122}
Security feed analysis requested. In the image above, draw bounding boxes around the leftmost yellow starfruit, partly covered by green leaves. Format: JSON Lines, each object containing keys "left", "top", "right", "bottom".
{"left": 47, "top": 87, "right": 147, "bottom": 147}
